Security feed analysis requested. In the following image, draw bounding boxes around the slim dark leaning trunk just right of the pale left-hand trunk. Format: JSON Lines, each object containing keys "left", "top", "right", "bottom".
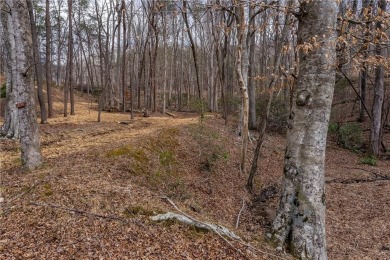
{"left": 26, "top": 0, "right": 47, "bottom": 124}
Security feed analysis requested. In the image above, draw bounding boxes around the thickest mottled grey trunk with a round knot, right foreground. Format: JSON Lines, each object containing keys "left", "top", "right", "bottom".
{"left": 272, "top": 0, "right": 338, "bottom": 259}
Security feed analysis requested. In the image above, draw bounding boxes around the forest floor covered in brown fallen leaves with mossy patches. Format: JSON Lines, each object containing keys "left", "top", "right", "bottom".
{"left": 0, "top": 88, "right": 390, "bottom": 259}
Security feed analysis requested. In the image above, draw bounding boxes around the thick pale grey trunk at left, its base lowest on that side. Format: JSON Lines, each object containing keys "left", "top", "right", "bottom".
{"left": 6, "top": 0, "right": 42, "bottom": 170}
